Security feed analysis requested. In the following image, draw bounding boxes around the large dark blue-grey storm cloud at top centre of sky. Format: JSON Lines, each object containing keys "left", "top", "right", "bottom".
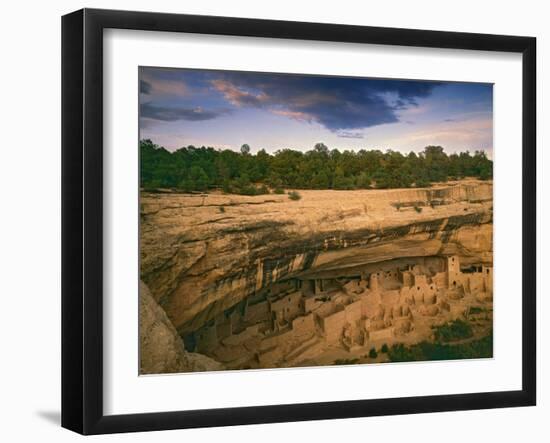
{"left": 209, "top": 72, "right": 444, "bottom": 132}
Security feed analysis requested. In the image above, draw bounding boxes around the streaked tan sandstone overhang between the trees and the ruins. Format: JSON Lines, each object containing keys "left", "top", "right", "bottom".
{"left": 140, "top": 180, "right": 493, "bottom": 336}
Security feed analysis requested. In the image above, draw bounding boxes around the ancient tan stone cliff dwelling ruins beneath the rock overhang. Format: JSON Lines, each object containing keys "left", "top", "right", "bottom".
{"left": 184, "top": 255, "right": 493, "bottom": 369}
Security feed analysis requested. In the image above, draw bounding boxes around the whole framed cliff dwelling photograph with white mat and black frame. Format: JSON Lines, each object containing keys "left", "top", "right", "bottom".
{"left": 62, "top": 9, "right": 536, "bottom": 434}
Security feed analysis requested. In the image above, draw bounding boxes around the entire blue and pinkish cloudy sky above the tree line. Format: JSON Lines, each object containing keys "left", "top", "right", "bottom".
{"left": 139, "top": 67, "right": 493, "bottom": 156}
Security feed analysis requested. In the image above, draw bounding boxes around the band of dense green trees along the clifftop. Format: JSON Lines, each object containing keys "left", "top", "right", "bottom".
{"left": 140, "top": 139, "right": 493, "bottom": 195}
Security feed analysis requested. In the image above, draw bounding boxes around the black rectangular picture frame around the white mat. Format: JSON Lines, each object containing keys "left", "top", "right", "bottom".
{"left": 62, "top": 9, "right": 536, "bottom": 434}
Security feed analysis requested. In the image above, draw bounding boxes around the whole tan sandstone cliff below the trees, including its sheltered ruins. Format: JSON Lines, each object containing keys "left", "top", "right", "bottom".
{"left": 140, "top": 180, "right": 493, "bottom": 373}
